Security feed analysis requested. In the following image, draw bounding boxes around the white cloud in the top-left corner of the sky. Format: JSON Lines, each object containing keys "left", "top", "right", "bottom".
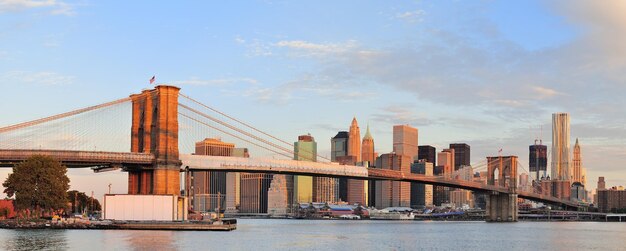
{"left": 0, "top": 0, "right": 75, "bottom": 16}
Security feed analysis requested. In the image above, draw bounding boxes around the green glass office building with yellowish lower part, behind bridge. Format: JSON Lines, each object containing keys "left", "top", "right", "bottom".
{"left": 293, "top": 134, "right": 317, "bottom": 203}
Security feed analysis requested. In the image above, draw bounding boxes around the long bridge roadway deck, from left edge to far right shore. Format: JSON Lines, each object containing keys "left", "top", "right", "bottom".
{"left": 0, "top": 149, "right": 579, "bottom": 208}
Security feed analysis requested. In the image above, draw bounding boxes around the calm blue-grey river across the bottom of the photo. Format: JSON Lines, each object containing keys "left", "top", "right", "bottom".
{"left": 0, "top": 219, "right": 626, "bottom": 251}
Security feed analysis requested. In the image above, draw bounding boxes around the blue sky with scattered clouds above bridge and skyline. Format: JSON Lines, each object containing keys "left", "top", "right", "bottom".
{"left": 0, "top": 0, "right": 626, "bottom": 200}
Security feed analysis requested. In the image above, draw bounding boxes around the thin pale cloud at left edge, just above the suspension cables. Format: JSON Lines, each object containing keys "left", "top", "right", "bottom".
{"left": 0, "top": 71, "right": 76, "bottom": 85}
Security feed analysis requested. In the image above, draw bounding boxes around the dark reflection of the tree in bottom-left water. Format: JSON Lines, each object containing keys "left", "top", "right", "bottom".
{"left": 1, "top": 229, "right": 68, "bottom": 250}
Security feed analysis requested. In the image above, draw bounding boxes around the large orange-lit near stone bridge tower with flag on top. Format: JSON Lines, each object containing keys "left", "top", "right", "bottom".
{"left": 128, "top": 85, "right": 182, "bottom": 195}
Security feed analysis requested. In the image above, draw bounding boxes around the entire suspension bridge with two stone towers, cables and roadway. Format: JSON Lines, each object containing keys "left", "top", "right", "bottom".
{"left": 0, "top": 85, "right": 585, "bottom": 221}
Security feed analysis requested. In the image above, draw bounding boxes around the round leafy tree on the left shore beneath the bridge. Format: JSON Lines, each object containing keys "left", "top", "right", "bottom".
{"left": 2, "top": 155, "right": 70, "bottom": 216}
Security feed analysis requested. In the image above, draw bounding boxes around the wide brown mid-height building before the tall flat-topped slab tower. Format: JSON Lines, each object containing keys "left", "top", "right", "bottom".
{"left": 375, "top": 153, "right": 413, "bottom": 209}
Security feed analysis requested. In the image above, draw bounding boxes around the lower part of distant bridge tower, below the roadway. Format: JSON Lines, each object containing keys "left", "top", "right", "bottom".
{"left": 487, "top": 193, "right": 517, "bottom": 222}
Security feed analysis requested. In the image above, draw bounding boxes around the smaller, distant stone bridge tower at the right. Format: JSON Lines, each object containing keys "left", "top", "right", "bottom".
{"left": 487, "top": 156, "right": 517, "bottom": 222}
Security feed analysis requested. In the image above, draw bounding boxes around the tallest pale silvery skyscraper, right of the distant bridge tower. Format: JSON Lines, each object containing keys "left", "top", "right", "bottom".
{"left": 551, "top": 113, "right": 571, "bottom": 180}
